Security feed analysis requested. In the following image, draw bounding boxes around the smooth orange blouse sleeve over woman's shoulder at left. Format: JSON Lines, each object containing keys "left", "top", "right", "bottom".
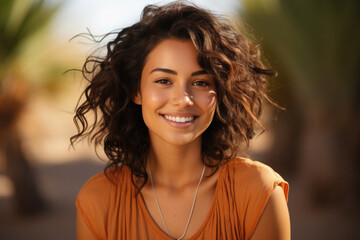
{"left": 75, "top": 173, "right": 111, "bottom": 240}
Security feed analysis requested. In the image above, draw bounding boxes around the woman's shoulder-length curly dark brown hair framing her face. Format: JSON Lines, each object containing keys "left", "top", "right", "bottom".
{"left": 71, "top": 1, "right": 274, "bottom": 189}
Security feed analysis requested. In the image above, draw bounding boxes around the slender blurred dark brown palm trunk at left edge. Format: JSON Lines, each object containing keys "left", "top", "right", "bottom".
{"left": 0, "top": 83, "right": 45, "bottom": 214}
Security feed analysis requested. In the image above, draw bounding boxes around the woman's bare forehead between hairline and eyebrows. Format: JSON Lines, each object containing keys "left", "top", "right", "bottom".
{"left": 143, "top": 39, "right": 202, "bottom": 73}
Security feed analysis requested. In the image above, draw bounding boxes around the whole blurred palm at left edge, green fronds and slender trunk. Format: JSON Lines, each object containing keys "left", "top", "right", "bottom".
{"left": 0, "top": 0, "right": 59, "bottom": 214}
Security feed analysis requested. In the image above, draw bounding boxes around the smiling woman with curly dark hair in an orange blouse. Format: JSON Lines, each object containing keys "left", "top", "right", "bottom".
{"left": 72, "top": 2, "right": 290, "bottom": 239}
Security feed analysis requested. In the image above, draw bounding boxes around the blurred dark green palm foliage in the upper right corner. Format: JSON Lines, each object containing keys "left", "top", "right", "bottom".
{"left": 242, "top": 0, "right": 360, "bottom": 107}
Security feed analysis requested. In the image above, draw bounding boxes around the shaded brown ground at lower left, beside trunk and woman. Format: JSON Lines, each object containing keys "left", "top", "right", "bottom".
{"left": 0, "top": 160, "right": 102, "bottom": 240}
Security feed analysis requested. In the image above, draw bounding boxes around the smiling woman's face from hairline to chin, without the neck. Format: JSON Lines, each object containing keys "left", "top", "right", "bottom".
{"left": 134, "top": 39, "right": 216, "bottom": 145}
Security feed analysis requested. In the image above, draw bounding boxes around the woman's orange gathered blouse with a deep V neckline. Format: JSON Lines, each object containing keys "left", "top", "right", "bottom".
{"left": 76, "top": 158, "right": 289, "bottom": 240}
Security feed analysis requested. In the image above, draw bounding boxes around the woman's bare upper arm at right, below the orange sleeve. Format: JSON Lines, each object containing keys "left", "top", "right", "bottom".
{"left": 251, "top": 186, "right": 291, "bottom": 240}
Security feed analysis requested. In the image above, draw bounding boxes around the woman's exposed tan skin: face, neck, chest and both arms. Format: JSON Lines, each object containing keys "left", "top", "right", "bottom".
{"left": 77, "top": 39, "right": 290, "bottom": 240}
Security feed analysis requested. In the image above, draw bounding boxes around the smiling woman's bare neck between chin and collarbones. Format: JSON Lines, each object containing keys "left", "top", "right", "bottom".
{"left": 148, "top": 139, "right": 204, "bottom": 188}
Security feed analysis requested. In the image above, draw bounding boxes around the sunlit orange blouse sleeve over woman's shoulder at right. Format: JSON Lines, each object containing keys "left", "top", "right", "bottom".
{"left": 235, "top": 159, "right": 289, "bottom": 239}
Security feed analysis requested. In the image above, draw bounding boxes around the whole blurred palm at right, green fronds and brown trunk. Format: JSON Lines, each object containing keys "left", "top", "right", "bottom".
{"left": 242, "top": 0, "right": 360, "bottom": 205}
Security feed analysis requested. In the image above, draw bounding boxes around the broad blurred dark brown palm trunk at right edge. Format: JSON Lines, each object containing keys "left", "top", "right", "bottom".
{"left": 299, "top": 113, "right": 360, "bottom": 209}
